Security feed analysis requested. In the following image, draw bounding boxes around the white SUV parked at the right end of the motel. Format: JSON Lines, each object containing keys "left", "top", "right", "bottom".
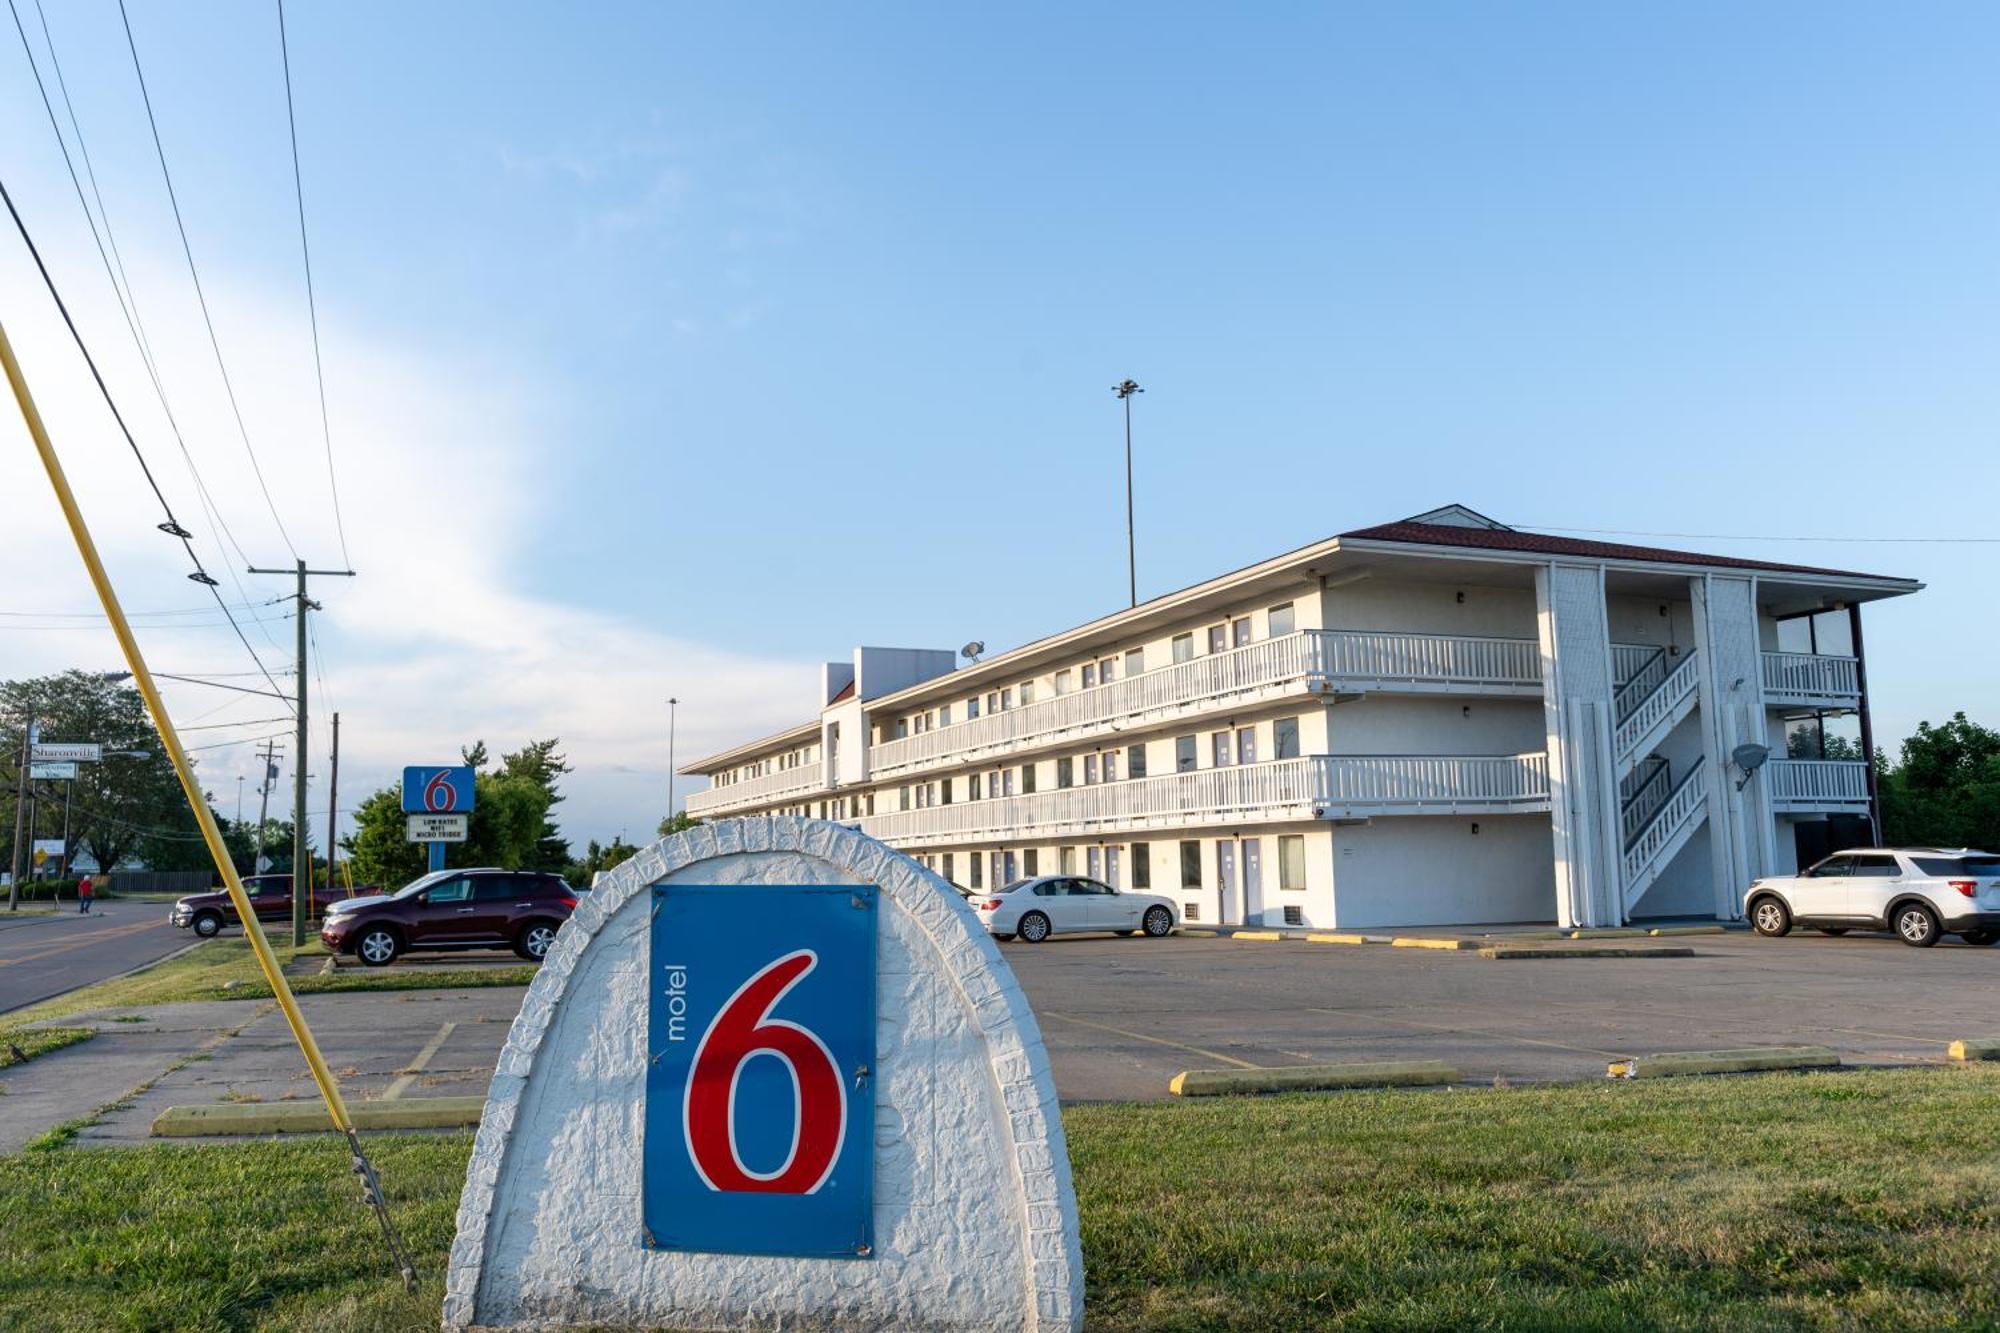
{"left": 1744, "top": 847, "right": 2000, "bottom": 949}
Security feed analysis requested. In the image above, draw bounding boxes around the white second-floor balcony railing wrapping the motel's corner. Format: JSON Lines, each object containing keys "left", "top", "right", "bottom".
{"left": 860, "top": 755, "right": 1548, "bottom": 847}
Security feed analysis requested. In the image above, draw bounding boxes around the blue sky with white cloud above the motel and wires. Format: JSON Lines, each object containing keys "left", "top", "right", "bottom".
{"left": 0, "top": 0, "right": 2000, "bottom": 839}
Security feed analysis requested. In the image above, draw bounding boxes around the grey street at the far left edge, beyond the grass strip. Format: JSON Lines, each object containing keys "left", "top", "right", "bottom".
{"left": 0, "top": 899, "right": 194, "bottom": 1013}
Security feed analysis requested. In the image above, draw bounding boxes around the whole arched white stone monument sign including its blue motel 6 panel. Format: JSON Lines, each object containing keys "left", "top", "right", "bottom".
{"left": 444, "top": 819, "right": 1084, "bottom": 1331}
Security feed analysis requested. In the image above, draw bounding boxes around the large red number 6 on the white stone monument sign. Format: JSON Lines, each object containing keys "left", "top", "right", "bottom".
{"left": 680, "top": 949, "right": 848, "bottom": 1195}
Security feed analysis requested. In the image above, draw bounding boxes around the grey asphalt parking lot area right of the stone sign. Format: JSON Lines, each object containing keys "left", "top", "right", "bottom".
{"left": 1002, "top": 931, "right": 2000, "bottom": 1101}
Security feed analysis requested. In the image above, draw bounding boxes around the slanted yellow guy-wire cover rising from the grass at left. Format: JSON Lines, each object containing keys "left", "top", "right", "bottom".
{"left": 0, "top": 324, "right": 354, "bottom": 1137}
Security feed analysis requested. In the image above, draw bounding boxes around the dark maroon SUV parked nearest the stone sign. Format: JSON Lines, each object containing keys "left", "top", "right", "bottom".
{"left": 320, "top": 869, "right": 576, "bottom": 967}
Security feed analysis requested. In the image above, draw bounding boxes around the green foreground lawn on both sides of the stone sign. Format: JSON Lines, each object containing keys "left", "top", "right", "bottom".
{"left": 0, "top": 1067, "right": 2000, "bottom": 1329}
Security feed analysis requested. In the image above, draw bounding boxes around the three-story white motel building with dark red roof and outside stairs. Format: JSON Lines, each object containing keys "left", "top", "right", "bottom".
{"left": 682, "top": 504, "right": 1922, "bottom": 929}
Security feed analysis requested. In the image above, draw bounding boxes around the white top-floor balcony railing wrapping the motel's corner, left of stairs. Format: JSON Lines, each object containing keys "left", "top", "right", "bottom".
{"left": 868, "top": 630, "right": 1542, "bottom": 777}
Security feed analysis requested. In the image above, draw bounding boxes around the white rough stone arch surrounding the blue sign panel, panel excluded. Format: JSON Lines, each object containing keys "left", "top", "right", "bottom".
{"left": 444, "top": 819, "right": 1084, "bottom": 1333}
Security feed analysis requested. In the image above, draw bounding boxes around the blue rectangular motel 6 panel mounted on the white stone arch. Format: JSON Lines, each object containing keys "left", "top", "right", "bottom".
{"left": 644, "top": 885, "right": 876, "bottom": 1259}
